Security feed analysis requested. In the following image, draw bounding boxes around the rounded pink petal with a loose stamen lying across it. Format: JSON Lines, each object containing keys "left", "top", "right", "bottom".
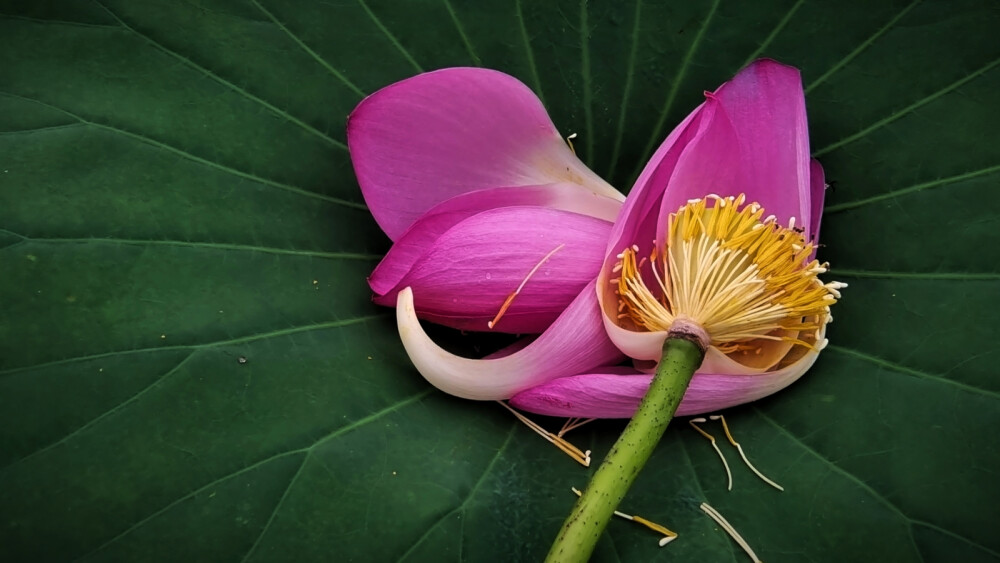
{"left": 375, "top": 207, "right": 611, "bottom": 334}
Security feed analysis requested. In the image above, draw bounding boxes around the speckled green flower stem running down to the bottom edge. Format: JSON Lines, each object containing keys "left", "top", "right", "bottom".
{"left": 545, "top": 337, "right": 705, "bottom": 563}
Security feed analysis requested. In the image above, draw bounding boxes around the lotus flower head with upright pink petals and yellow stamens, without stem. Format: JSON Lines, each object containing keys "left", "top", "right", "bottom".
{"left": 511, "top": 60, "right": 844, "bottom": 418}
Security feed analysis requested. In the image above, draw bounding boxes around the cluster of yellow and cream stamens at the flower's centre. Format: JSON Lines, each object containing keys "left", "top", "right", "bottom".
{"left": 612, "top": 194, "right": 846, "bottom": 354}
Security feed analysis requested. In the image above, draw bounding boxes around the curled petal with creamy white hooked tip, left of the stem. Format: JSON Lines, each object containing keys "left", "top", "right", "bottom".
{"left": 396, "top": 283, "right": 622, "bottom": 400}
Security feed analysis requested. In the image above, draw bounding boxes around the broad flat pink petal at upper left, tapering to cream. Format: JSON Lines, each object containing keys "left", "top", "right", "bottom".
{"left": 347, "top": 68, "right": 624, "bottom": 240}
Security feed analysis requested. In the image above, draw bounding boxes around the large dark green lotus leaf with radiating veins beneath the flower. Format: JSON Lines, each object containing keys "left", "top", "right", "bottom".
{"left": 0, "top": 0, "right": 1000, "bottom": 563}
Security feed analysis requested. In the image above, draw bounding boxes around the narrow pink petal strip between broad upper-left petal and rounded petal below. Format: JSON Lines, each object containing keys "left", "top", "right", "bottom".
{"left": 368, "top": 183, "right": 621, "bottom": 302}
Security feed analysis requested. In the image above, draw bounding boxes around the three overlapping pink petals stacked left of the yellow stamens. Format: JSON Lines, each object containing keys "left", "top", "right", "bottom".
{"left": 347, "top": 68, "right": 624, "bottom": 334}
